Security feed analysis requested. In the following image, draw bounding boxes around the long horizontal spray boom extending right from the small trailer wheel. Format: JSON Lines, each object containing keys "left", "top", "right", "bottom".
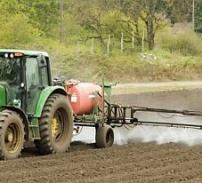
{"left": 107, "top": 103, "right": 202, "bottom": 130}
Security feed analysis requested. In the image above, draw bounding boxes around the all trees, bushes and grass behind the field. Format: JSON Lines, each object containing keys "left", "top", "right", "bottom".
{"left": 0, "top": 0, "right": 202, "bottom": 81}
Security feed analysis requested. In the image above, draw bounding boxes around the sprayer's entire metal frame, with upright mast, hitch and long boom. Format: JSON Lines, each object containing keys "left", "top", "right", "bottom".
{"left": 74, "top": 81, "right": 202, "bottom": 130}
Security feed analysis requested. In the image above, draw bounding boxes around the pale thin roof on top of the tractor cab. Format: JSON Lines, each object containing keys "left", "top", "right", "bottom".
{"left": 0, "top": 49, "right": 48, "bottom": 57}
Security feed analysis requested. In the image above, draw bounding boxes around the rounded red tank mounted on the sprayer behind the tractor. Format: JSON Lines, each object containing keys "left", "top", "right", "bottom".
{"left": 65, "top": 81, "right": 102, "bottom": 115}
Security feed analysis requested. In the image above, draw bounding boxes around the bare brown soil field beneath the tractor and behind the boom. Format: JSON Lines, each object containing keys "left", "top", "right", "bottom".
{"left": 0, "top": 86, "right": 202, "bottom": 183}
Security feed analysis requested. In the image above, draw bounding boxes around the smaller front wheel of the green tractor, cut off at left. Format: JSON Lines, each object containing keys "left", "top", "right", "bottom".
{"left": 0, "top": 110, "right": 25, "bottom": 160}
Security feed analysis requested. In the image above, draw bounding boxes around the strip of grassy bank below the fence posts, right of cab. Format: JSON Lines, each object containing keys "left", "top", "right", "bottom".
{"left": 48, "top": 46, "right": 202, "bottom": 82}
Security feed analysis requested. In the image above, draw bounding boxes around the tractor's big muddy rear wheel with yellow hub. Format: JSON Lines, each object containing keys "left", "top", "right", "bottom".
{"left": 35, "top": 94, "right": 73, "bottom": 154}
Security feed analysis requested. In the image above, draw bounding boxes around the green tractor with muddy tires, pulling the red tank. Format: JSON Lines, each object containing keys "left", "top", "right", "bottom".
{"left": 0, "top": 49, "right": 73, "bottom": 159}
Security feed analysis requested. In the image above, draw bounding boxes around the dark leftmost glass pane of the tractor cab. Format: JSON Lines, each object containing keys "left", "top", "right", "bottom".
{"left": 0, "top": 57, "right": 20, "bottom": 84}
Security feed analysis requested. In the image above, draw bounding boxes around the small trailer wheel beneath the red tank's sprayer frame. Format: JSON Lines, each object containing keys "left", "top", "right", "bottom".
{"left": 96, "top": 124, "right": 114, "bottom": 148}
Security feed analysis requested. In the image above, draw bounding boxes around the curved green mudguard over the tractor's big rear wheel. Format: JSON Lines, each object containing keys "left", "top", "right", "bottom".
{"left": 34, "top": 86, "right": 67, "bottom": 118}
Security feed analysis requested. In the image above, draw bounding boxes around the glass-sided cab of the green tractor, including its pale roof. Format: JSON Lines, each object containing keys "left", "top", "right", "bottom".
{"left": 0, "top": 50, "right": 51, "bottom": 114}
